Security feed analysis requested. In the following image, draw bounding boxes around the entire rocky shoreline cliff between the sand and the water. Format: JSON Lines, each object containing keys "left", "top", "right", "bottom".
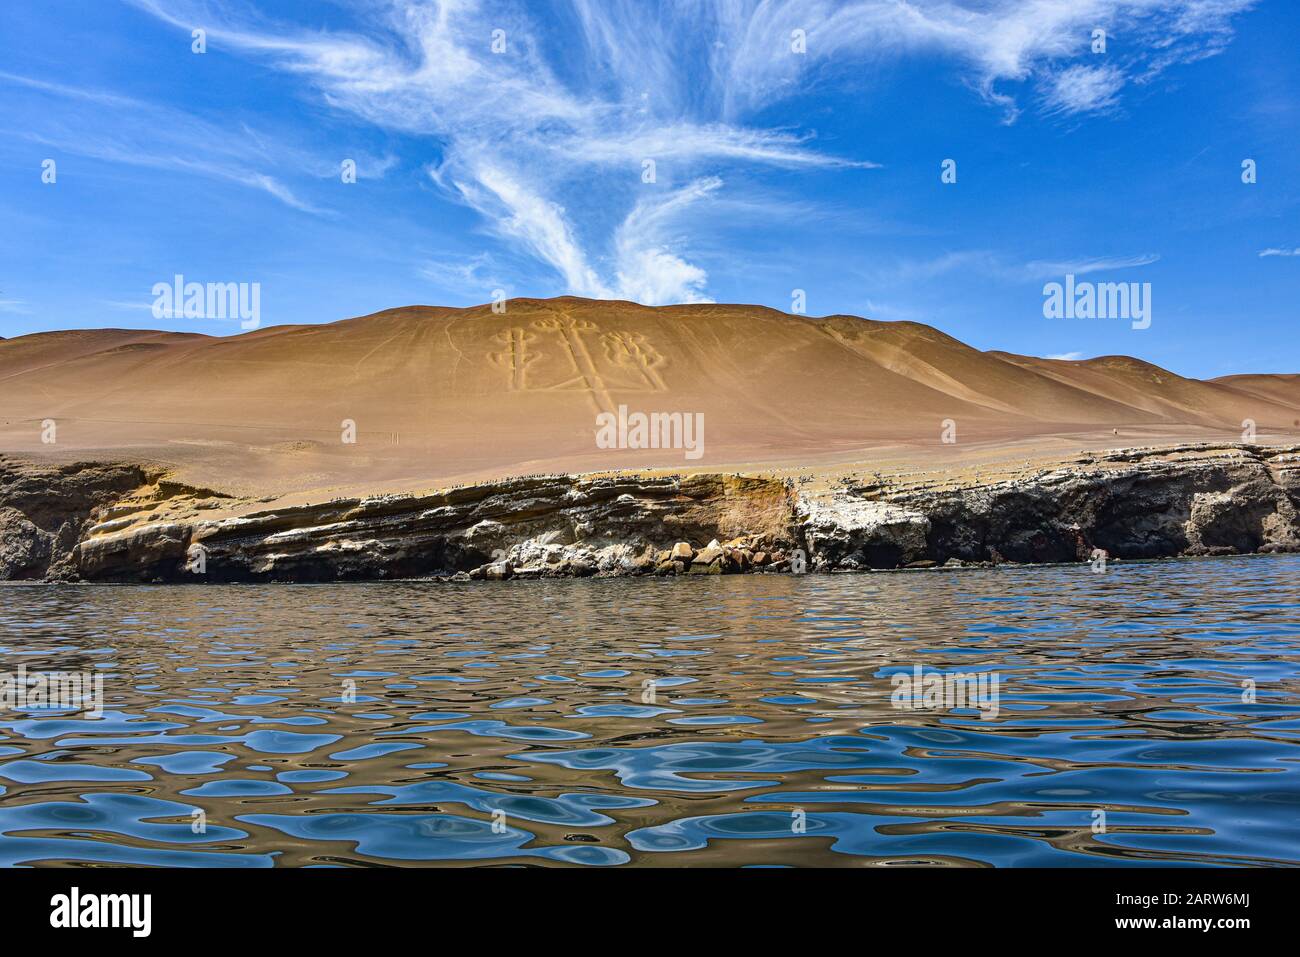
{"left": 0, "top": 445, "right": 1300, "bottom": 581}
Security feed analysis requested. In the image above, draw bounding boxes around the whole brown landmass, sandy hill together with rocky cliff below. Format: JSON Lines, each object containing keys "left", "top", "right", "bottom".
{"left": 0, "top": 298, "right": 1300, "bottom": 581}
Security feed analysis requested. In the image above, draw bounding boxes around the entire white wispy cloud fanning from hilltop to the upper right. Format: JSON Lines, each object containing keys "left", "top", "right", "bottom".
{"left": 130, "top": 0, "right": 1255, "bottom": 302}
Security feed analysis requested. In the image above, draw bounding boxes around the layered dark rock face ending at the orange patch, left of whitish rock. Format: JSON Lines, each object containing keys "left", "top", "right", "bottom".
{"left": 65, "top": 476, "right": 792, "bottom": 581}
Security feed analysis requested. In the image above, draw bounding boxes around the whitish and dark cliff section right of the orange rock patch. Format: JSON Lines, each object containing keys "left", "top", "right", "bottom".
{"left": 801, "top": 445, "right": 1300, "bottom": 570}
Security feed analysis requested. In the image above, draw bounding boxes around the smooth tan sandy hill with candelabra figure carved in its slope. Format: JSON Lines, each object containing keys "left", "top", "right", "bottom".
{"left": 0, "top": 298, "right": 1300, "bottom": 489}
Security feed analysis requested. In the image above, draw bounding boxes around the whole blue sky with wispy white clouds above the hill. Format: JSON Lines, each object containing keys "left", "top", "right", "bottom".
{"left": 0, "top": 0, "right": 1300, "bottom": 377}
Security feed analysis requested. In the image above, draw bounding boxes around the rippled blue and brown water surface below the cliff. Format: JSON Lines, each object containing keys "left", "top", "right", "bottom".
{"left": 0, "top": 557, "right": 1300, "bottom": 867}
